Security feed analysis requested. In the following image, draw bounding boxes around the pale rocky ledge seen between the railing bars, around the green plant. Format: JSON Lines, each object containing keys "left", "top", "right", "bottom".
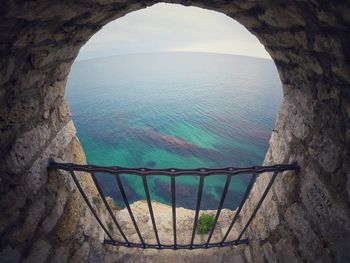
{"left": 106, "top": 201, "right": 240, "bottom": 244}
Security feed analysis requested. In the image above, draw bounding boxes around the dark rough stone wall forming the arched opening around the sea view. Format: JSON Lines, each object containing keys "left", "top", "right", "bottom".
{"left": 0, "top": 0, "right": 350, "bottom": 262}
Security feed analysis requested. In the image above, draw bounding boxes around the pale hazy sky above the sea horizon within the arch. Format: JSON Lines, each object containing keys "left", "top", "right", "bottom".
{"left": 78, "top": 4, "right": 270, "bottom": 60}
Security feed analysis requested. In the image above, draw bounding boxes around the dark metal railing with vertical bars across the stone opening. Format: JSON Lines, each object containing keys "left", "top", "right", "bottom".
{"left": 49, "top": 161, "right": 299, "bottom": 249}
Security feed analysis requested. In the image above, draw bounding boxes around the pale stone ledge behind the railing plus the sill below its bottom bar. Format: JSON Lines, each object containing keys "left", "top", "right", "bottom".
{"left": 96, "top": 198, "right": 245, "bottom": 263}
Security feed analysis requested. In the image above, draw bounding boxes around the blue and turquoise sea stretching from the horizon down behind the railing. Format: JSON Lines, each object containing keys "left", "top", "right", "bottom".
{"left": 66, "top": 52, "right": 282, "bottom": 209}
